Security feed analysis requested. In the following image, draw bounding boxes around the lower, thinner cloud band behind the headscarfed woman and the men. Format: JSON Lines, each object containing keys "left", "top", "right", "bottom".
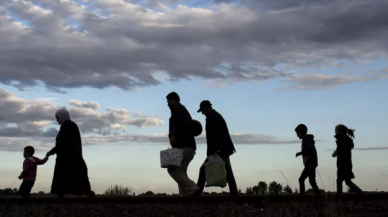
{"left": 0, "top": 89, "right": 300, "bottom": 151}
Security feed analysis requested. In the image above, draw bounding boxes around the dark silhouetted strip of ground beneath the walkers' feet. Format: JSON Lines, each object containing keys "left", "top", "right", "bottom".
{"left": 0, "top": 194, "right": 388, "bottom": 217}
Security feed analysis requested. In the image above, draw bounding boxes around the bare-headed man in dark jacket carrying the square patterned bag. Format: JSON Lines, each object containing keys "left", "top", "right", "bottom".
{"left": 166, "top": 92, "right": 200, "bottom": 196}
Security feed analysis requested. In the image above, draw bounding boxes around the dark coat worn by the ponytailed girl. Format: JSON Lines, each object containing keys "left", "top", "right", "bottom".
{"left": 335, "top": 134, "right": 355, "bottom": 179}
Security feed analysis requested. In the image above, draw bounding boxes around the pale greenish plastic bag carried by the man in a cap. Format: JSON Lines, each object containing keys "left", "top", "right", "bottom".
{"left": 205, "top": 154, "right": 227, "bottom": 188}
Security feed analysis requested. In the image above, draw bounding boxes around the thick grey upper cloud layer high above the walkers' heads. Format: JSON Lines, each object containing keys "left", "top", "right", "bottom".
{"left": 0, "top": 0, "right": 388, "bottom": 92}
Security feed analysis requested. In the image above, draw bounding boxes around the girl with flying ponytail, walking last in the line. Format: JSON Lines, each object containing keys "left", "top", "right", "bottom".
{"left": 332, "top": 124, "right": 362, "bottom": 194}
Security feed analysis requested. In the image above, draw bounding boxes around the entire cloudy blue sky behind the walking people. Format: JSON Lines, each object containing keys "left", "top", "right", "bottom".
{"left": 0, "top": 0, "right": 388, "bottom": 193}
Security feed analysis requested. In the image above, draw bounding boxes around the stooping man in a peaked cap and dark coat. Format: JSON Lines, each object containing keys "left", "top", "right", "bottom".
{"left": 197, "top": 100, "right": 238, "bottom": 196}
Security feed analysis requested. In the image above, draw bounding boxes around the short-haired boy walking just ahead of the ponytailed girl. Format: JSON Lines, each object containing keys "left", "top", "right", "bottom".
{"left": 295, "top": 124, "right": 321, "bottom": 195}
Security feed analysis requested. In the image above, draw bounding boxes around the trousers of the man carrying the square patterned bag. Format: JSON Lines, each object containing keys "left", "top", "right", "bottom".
{"left": 167, "top": 148, "right": 199, "bottom": 196}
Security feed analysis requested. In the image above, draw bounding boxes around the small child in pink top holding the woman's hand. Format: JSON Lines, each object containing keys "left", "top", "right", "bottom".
{"left": 18, "top": 146, "right": 48, "bottom": 197}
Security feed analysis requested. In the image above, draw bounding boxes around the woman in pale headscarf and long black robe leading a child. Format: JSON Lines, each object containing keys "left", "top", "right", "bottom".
{"left": 46, "top": 109, "right": 94, "bottom": 197}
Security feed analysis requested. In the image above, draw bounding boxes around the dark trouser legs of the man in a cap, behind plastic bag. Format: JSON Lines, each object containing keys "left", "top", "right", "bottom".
{"left": 197, "top": 155, "right": 238, "bottom": 195}
